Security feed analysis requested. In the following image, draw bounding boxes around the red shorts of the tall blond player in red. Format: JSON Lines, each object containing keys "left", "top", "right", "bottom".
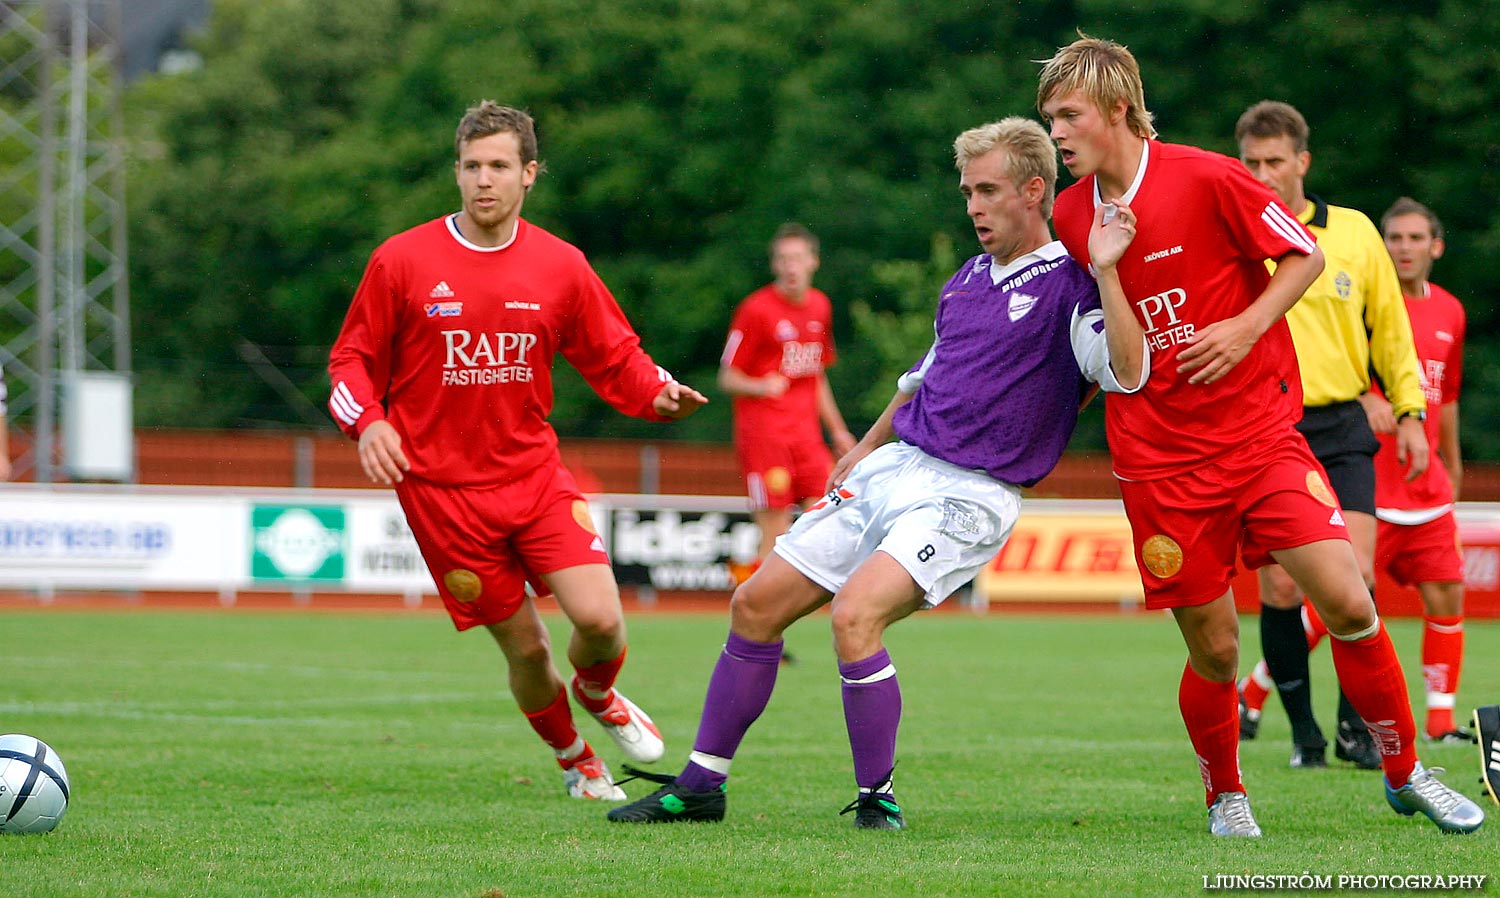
{"left": 1121, "top": 427, "right": 1349, "bottom": 609}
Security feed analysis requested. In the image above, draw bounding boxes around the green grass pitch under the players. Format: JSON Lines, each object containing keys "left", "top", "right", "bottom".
{"left": 0, "top": 610, "right": 1500, "bottom": 898}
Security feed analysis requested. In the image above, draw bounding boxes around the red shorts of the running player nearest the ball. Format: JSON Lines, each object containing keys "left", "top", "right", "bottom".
{"left": 396, "top": 463, "right": 609, "bottom": 630}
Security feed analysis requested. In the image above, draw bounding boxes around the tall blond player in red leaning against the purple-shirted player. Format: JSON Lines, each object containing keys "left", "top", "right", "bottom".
{"left": 1037, "top": 37, "right": 1484, "bottom": 837}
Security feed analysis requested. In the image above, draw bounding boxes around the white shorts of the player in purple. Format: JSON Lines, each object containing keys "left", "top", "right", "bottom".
{"left": 776, "top": 442, "right": 1022, "bottom": 607}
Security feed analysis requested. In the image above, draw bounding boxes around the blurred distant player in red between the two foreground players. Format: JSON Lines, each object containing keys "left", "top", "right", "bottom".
{"left": 719, "top": 223, "right": 855, "bottom": 580}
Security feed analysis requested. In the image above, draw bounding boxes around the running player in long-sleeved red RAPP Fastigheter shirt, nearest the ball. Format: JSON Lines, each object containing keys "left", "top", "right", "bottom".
{"left": 329, "top": 100, "right": 707, "bottom": 801}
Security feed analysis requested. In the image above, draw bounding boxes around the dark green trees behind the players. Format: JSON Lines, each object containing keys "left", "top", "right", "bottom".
{"left": 117, "top": 0, "right": 1500, "bottom": 460}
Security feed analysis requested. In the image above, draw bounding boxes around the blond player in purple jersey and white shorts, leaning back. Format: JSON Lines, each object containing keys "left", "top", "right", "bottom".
{"left": 609, "top": 118, "right": 1148, "bottom": 829}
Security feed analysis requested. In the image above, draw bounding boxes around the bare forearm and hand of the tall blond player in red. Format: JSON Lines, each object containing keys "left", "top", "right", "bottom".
{"left": 1178, "top": 247, "right": 1323, "bottom": 384}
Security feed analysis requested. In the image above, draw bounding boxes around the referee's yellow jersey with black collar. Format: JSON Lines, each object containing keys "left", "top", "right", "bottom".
{"left": 1272, "top": 193, "right": 1427, "bottom": 415}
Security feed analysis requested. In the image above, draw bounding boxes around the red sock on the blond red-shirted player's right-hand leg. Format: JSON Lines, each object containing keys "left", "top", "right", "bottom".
{"left": 1332, "top": 622, "right": 1416, "bottom": 787}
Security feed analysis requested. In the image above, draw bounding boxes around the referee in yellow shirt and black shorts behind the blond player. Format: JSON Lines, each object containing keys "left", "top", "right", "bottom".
{"left": 1235, "top": 100, "right": 1428, "bottom": 771}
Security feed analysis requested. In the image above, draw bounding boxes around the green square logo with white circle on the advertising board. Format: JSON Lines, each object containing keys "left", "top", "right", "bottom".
{"left": 251, "top": 505, "right": 347, "bottom": 582}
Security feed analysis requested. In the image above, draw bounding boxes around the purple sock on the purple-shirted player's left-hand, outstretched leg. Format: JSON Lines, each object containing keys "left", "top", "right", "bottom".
{"left": 677, "top": 633, "right": 782, "bottom": 792}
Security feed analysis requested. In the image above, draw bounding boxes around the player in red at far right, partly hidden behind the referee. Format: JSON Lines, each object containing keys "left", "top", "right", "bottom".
{"left": 1367, "top": 196, "right": 1470, "bottom": 742}
